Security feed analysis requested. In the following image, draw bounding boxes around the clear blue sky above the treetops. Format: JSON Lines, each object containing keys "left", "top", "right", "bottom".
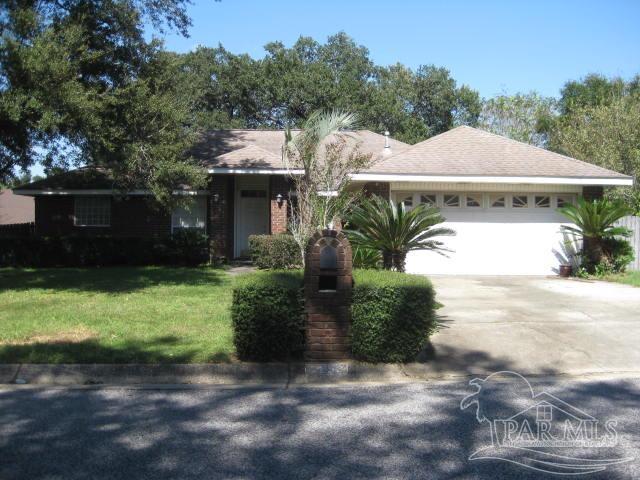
{"left": 159, "top": 0, "right": 640, "bottom": 97}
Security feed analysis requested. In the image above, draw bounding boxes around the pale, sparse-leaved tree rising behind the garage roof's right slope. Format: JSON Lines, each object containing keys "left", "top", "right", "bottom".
{"left": 478, "top": 92, "right": 556, "bottom": 147}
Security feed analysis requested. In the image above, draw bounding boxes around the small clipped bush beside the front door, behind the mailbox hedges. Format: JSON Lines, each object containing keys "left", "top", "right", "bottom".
{"left": 249, "top": 234, "right": 302, "bottom": 270}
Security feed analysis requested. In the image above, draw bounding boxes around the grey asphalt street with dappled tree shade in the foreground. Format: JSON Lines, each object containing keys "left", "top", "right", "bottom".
{"left": 0, "top": 379, "right": 640, "bottom": 480}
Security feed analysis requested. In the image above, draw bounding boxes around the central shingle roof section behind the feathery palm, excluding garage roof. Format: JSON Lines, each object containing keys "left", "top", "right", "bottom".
{"left": 191, "top": 130, "right": 410, "bottom": 170}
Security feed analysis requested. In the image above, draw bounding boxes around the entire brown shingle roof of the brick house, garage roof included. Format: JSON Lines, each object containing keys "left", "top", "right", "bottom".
{"left": 14, "top": 126, "right": 630, "bottom": 193}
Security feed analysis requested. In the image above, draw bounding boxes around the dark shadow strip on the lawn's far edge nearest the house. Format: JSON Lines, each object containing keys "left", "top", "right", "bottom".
{"left": 0, "top": 267, "right": 227, "bottom": 293}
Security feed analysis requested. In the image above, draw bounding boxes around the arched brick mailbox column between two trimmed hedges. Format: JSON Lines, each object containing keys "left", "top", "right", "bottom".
{"left": 304, "top": 230, "right": 353, "bottom": 361}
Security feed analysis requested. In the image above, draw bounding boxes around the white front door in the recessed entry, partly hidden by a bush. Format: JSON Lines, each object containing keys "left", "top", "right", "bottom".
{"left": 234, "top": 175, "right": 269, "bottom": 257}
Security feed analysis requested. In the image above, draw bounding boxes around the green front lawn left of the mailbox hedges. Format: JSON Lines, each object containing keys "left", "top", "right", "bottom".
{"left": 0, "top": 267, "right": 234, "bottom": 363}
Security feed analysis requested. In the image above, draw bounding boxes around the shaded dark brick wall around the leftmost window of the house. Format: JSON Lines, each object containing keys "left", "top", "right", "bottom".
{"left": 35, "top": 196, "right": 171, "bottom": 237}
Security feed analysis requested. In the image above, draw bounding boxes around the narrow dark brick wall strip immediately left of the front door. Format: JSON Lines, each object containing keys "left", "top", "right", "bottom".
{"left": 207, "top": 175, "right": 235, "bottom": 259}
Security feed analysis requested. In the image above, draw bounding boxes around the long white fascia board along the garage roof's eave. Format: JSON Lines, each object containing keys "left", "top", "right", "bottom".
{"left": 351, "top": 173, "right": 633, "bottom": 186}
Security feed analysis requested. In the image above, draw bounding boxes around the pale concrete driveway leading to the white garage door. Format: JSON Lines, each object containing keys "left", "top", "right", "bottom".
{"left": 430, "top": 276, "right": 640, "bottom": 376}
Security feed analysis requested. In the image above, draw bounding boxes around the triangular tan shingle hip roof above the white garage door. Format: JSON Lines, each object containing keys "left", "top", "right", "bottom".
{"left": 369, "top": 126, "right": 630, "bottom": 178}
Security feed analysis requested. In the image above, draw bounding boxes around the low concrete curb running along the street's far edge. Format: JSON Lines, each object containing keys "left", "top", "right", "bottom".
{"left": 5, "top": 361, "right": 640, "bottom": 388}
